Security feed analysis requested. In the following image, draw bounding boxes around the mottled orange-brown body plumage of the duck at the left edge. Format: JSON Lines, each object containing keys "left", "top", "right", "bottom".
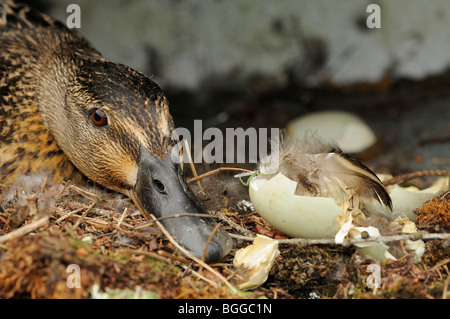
{"left": 0, "top": 20, "right": 73, "bottom": 185}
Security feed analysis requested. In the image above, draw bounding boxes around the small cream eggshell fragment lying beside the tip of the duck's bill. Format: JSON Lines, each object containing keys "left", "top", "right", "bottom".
{"left": 233, "top": 235, "right": 280, "bottom": 289}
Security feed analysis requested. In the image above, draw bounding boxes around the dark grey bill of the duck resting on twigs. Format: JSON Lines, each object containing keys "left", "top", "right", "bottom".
{"left": 132, "top": 149, "right": 232, "bottom": 263}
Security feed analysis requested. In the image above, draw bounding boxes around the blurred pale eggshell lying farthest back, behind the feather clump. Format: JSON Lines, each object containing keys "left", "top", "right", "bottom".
{"left": 286, "top": 111, "right": 376, "bottom": 153}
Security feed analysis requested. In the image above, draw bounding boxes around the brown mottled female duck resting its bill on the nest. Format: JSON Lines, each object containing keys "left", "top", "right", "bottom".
{"left": 0, "top": 0, "right": 231, "bottom": 262}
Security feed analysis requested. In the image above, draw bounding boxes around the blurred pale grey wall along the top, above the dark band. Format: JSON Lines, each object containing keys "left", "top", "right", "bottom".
{"left": 37, "top": 0, "right": 450, "bottom": 91}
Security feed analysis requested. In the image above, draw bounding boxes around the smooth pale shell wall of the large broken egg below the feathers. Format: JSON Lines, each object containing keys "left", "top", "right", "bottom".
{"left": 249, "top": 173, "right": 342, "bottom": 238}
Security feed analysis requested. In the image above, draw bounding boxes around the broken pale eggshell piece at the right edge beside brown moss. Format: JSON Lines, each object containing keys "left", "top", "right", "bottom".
{"left": 389, "top": 177, "right": 449, "bottom": 221}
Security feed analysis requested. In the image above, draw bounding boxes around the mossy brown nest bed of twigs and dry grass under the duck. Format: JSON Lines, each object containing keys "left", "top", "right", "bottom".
{"left": 0, "top": 174, "right": 450, "bottom": 298}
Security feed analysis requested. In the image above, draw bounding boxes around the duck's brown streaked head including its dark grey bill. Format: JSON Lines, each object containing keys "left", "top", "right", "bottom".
{"left": 39, "top": 59, "right": 232, "bottom": 262}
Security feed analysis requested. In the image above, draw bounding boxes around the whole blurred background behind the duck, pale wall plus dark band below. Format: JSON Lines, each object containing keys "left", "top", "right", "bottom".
{"left": 19, "top": 0, "right": 450, "bottom": 173}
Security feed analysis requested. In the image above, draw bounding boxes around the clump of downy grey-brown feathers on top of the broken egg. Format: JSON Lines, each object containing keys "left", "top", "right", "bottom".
{"left": 259, "top": 135, "right": 392, "bottom": 214}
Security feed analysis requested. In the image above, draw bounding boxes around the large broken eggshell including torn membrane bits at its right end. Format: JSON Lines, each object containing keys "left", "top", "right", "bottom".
{"left": 249, "top": 173, "right": 395, "bottom": 261}
